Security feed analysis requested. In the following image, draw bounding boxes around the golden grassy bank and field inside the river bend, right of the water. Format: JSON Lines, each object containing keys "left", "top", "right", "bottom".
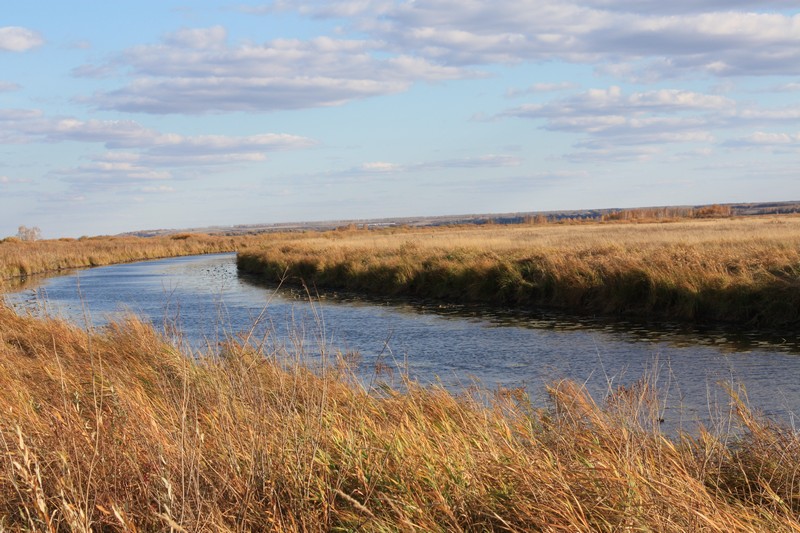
{"left": 238, "top": 216, "right": 800, "bottom": 328}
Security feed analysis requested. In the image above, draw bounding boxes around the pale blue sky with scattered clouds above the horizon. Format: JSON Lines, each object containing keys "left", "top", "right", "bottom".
{"left": 0, "top": 0, "right": 800, "bottom": 238}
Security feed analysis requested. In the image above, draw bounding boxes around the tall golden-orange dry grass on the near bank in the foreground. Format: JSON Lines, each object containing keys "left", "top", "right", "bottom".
{"left": 0, "top": 308, "right": 800, "bottom": 532}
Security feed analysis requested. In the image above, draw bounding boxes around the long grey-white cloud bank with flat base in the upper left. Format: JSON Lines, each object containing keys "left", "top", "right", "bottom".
{"left": 81, "top": 27, "right": 477, "bottom": 114}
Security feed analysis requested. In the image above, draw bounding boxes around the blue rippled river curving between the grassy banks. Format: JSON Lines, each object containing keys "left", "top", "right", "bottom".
{"left": 6, "top": 254, "right": 800, "bottom": 428}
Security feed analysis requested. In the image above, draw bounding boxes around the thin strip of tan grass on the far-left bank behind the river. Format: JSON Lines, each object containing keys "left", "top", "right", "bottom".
{"left": 0, "top": 233, "right": 255, "bottom": 281}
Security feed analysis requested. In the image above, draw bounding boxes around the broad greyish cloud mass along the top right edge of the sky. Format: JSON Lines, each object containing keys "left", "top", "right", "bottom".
{"left": 255, "top": 0, "right": 800, "bottom": 79}
